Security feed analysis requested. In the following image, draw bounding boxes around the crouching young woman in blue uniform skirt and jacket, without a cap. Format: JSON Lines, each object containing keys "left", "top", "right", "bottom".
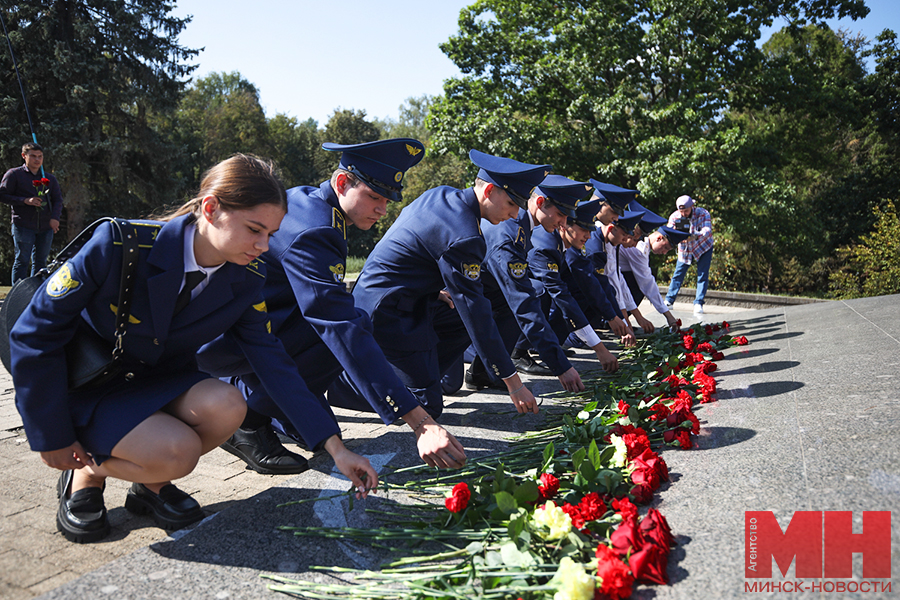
{"left": 10, "top": 155, "right": 377, "bottom": 542}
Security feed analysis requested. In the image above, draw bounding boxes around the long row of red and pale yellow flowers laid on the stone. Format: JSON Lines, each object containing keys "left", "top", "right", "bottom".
{"left": 264, "top": 323, "right": 747, "bottom": 600}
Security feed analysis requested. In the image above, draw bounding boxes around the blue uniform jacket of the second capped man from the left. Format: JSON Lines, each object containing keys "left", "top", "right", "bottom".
{"left": 353, "top": 186, "right": 516, "bottom": 377}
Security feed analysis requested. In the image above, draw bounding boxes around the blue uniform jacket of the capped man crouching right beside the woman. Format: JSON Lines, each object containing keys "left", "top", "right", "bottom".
{"left": 198, "top": 181, "right": 419, "bottom": 423}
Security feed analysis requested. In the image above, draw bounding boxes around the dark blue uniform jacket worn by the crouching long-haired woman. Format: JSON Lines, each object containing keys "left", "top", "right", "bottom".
{"left": 10, "top": 215, "right": 339, "bottom": 451}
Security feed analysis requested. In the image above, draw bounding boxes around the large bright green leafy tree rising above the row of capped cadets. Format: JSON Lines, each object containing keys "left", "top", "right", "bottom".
{"left": 428, "top": 0, "right": 868, "bottom": 296}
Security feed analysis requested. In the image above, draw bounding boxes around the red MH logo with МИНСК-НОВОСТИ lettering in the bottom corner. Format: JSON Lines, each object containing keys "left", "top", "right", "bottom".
{"left": 744, "top": 511, "right": 891, "bottom": 592}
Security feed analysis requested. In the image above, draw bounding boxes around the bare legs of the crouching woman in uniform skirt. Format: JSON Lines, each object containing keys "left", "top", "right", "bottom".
{"left": 72, "top": 379, "right": 247, "bottom": 493}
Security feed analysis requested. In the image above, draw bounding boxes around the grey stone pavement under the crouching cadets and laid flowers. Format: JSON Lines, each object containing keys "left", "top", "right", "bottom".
{"left": 0, "top": 296, "right": 900, "bottom": 599}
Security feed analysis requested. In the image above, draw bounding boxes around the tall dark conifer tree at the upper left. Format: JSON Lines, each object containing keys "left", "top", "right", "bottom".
{"left": 0, "top": 0, "right": 196, "bottom": 250}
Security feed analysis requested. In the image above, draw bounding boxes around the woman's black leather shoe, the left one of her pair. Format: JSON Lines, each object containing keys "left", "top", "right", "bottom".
{"left": 56, "top": 469, "right": 109, "bottom": 544}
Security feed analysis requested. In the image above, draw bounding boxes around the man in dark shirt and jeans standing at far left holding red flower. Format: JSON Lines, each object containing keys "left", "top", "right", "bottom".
{"left": 0, "top": 142, "right": 63, "bottom": 285}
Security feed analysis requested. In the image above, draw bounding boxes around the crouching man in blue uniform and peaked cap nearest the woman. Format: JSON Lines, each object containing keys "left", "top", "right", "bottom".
{"left": 198, "top": 138, "right": 465, "bottom": 474}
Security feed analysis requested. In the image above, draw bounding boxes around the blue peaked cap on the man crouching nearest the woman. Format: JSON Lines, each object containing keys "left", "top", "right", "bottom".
{"left": 322, "top": 138, "right": 425, "bottom": 201}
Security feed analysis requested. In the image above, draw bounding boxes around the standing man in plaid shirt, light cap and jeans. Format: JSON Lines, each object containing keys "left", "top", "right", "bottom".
{"left": 666, "top": 195, "right": 713, "bottom": 317}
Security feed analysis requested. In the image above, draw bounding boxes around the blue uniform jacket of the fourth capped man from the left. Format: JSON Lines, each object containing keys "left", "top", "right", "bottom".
{"left": 528, "top": 227, "right": 589, "bottom": 331}
